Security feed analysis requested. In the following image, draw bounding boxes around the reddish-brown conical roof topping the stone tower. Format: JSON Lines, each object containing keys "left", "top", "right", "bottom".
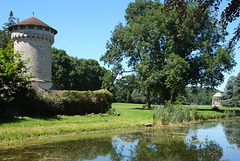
{"left": 9, "top": 17, "right": 57, "bottom": 34}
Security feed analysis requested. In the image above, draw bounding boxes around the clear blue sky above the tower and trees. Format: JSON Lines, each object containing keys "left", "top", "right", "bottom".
{"left": 0, "top": 0, "right": 240, "bottom": 91}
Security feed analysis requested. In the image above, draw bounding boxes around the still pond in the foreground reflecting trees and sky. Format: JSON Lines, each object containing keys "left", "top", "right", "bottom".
{"left": 0, "top": 118, "right": 240, "bottom": 161}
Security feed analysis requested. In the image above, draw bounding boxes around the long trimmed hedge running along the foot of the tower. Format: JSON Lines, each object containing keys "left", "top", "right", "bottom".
{"left": 0, "top": 90, "right": 113, "bottom": 117}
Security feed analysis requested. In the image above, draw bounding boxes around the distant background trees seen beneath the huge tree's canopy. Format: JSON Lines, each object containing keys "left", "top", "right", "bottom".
{"left": 107, "top": 74, "right": 219, "bottom": 105}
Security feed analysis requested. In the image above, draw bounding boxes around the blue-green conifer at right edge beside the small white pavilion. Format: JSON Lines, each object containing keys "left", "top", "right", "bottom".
{"left": 222, "top": 73, "right": 240, "bottom": 107}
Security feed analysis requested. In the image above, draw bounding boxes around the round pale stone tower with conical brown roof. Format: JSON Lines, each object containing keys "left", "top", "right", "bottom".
{"left": 9, "top": 17, "right": 57, "bottom": 90}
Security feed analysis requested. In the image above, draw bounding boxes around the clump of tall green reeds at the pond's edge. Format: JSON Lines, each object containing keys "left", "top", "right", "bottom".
{"left": 153, "top": 103, "right": 197, "bottom": 124}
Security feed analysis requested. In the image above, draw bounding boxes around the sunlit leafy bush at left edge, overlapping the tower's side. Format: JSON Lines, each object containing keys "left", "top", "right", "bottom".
{"left": 0, "top": 41, "right": 30, "bottom": 110}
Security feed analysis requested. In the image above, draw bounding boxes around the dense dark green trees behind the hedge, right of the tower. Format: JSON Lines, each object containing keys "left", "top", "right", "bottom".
{"left": 52, "top": 48, "right": 106, "bottom": 91}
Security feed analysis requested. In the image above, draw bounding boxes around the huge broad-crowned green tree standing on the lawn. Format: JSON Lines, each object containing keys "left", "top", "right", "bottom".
{"left": 101, "top": 0, "right": 235, "bottom": 108}
